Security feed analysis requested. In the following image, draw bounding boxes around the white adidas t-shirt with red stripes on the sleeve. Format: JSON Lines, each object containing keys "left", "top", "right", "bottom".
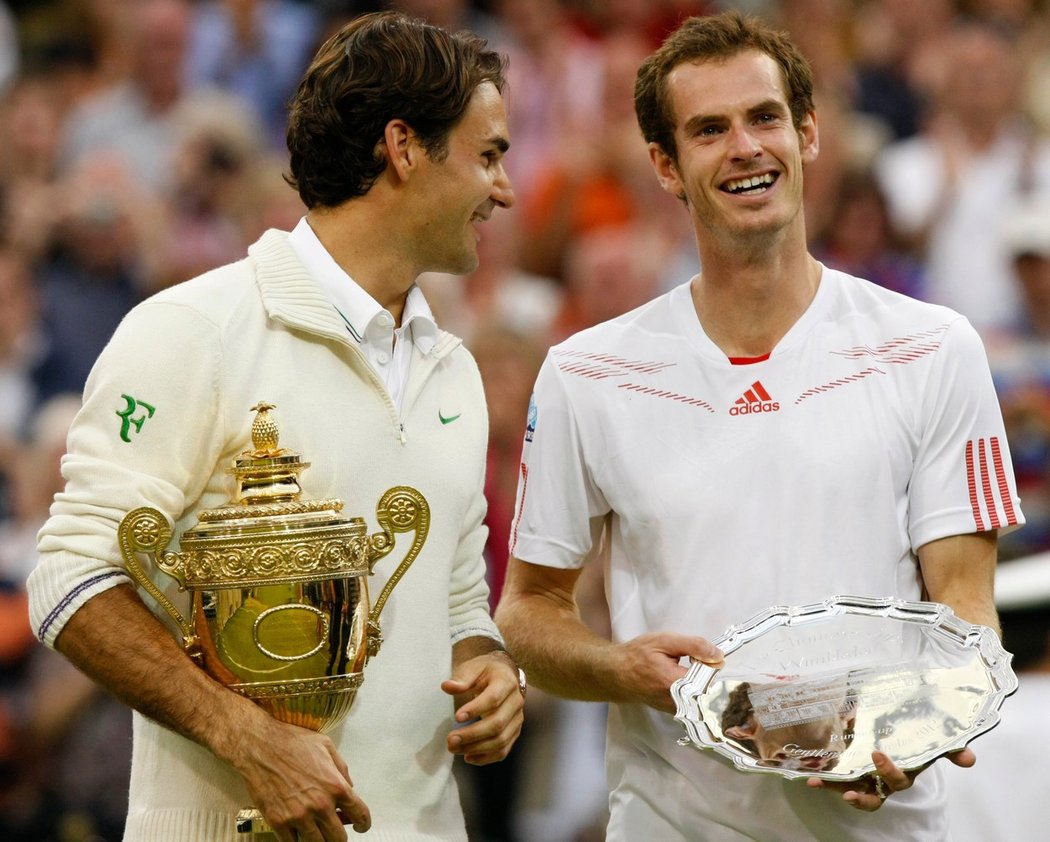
{"left": 511, "top": 269, "right": 1024, "bottom": 842}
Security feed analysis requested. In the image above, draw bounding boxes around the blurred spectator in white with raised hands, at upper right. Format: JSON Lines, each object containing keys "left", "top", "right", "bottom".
{"left": 876, "top": 21, "right": 1050, "bottom": 338}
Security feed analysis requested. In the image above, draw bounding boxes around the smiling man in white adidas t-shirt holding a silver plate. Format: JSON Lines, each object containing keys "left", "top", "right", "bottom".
{"left": 497, "top": 13, "right": 1023, "bottom": 842}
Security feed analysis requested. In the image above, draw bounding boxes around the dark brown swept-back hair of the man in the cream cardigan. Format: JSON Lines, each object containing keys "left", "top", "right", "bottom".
{"left": 288, "top": 12, "right": 505, "bottom": 208}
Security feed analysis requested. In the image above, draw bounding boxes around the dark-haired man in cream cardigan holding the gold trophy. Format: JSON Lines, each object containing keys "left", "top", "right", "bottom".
{"left": 29, "top": 14, "right": 524, "bottom": 842}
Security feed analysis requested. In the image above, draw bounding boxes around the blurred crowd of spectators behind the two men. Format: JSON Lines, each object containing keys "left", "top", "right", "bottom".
{"left": 0, "top": 0, "right": 1050, "bottom": 842}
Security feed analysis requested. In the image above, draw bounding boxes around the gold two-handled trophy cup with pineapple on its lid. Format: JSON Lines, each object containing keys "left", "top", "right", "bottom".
{"left": 118, "top": 402, "right": 431, "bottom": 840}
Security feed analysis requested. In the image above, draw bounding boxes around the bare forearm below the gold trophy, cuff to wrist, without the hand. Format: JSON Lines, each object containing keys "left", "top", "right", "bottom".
{"left": 56, "top": 585, "right": 269, "bottom": 762}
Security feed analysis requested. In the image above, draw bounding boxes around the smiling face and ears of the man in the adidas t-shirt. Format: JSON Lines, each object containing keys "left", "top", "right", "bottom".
{"left": 649, "top": 49, "right": 818, "bottom": 254}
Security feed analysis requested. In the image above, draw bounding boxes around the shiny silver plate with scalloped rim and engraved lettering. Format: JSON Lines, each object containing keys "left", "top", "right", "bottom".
{"left": 671, "top": 596, "right": 1017, "bottom": 780}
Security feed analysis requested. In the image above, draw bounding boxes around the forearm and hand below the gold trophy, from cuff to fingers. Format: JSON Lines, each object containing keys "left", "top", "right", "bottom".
{"left": 56, "top": 585, "right": 371, "bottom": 839}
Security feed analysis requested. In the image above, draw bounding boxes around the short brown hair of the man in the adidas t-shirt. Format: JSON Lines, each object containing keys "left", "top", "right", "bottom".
{"left": 634, "top": 12, "right": 813, "bottom": 159}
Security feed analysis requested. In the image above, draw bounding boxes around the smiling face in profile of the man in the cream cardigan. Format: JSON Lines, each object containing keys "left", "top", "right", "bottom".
{"left": 415, "top": 82, "right": 515, "bottom": 274}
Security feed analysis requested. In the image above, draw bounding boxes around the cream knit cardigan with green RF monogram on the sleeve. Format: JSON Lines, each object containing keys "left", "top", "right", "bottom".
{"left": 29, "top": 231, "right": 499, "bottom": 842}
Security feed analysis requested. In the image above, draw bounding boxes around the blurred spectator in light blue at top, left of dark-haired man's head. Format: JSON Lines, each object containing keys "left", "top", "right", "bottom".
{"left": 184, "top": 0, "right": 321, "bottom": 149}
